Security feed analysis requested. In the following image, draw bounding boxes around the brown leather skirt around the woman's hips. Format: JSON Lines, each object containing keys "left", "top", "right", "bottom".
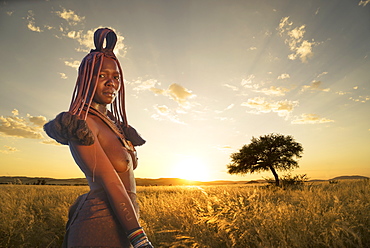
{"left": 63, "top": 190, "right": 138, "bottom": 248}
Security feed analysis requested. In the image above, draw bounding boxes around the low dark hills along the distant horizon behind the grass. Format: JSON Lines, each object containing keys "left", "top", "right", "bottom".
{"left": 0, "top": 175, "right": 369, "bottom": 186}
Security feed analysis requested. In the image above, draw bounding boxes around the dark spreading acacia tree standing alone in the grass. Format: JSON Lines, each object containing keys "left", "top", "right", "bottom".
{"left": 227, "top": 133, "right": 303, "bottom": 186}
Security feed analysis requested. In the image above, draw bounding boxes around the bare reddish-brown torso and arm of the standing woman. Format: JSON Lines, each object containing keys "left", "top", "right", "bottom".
{"left": 69, "top": 107, "right": 139, "bottom": 226}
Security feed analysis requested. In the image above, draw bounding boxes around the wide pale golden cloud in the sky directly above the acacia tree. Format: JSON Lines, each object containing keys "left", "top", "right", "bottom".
{"left": 241, "top": 97, "right": 298, "bottom": 117}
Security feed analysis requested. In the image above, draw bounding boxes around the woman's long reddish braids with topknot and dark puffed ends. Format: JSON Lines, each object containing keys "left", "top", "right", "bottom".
{"left": 44, "top": 28, "right": 145, "bottom": 146}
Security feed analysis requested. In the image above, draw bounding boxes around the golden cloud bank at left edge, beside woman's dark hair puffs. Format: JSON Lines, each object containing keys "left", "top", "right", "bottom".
{"left": 0, "top": 109, "right": 46, "bottom": 139}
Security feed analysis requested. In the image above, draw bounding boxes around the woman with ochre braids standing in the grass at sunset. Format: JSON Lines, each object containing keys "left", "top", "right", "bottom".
{"left": 44, "top": 28, "right": 153, "bottom": 248}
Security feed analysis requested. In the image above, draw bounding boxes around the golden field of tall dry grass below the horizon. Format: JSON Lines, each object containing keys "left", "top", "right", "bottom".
{"left": 0, "top": 180, "right": 370, "bottom": 248}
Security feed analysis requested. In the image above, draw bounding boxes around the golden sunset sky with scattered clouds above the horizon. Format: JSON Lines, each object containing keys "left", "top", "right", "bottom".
{"left": 0, "top": 0, "right": 370, "bottom": 181}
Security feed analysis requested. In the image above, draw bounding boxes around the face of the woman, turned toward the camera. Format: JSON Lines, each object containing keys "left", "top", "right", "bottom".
{"left": 93, "top": 57, "right": 121, "bottom": 105}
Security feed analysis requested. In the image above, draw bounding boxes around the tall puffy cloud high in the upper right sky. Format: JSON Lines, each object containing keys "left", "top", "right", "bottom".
{"left": 277, "top": 17, "right": 319, "bottom": 63}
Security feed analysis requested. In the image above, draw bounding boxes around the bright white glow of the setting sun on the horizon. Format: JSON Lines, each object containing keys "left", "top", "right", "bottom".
{"left": 173, "top": 157, "right": 210, "bottom": 181}
